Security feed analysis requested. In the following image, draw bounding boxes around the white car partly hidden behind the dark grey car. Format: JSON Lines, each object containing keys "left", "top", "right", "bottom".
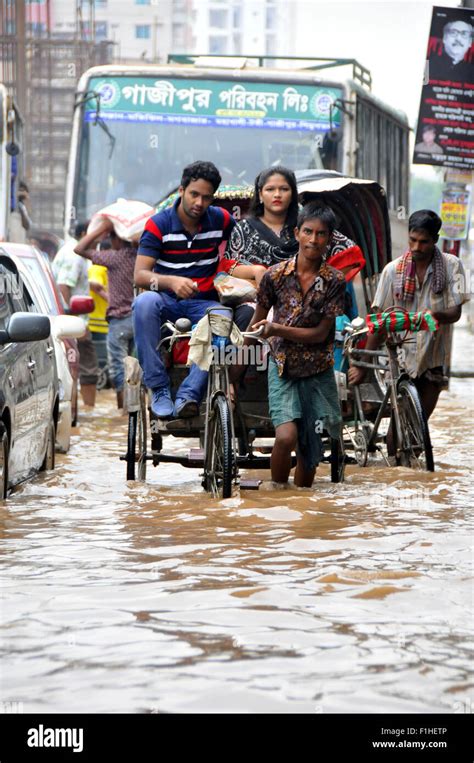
{"left": 0, "top": 243, "right": 94, "bottom": 453}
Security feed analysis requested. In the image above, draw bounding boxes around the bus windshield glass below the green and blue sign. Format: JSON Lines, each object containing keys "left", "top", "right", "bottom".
{"left": 74, "top": 122, "right": 323, "bottom": 220}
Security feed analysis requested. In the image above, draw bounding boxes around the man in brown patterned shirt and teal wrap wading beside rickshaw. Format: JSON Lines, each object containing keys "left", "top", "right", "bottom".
{"left": 248, "top": 204, "right": 345, "bottom": 487}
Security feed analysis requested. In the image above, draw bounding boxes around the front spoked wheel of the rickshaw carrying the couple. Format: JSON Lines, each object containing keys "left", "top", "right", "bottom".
{"left": 203, "top": 395, "right": 234, "bottom": 498}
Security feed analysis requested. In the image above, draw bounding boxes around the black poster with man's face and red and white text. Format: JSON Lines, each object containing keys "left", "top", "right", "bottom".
{"left": 413, "top": 7, "right": 474, "bottom": 170}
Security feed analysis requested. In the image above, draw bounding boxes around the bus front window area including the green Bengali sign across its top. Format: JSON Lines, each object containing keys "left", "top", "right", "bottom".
{"left": 73, "top": 77, "right": 340, "bottom": 220}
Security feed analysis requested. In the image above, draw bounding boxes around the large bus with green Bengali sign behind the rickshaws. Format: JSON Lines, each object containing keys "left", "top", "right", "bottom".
{"left": 65, "top": 56, "right": 409, "bottom": 253}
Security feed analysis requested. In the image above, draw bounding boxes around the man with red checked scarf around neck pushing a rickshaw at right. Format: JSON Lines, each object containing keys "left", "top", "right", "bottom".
{"left": 349, "top": 209, "right": 469, "bottom": 418}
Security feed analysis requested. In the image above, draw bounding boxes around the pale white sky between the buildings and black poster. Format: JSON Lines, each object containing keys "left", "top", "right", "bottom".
{"left": 288, "top": 0, "right": 459, "bottom": 177}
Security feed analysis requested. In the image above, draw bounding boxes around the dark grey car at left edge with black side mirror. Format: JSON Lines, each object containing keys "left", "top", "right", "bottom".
{"left": 0, "top": 252, "right": 59, "bottom": 499}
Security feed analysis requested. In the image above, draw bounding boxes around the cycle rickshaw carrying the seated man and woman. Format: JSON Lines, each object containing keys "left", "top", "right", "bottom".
{"left": 122, "top": 186, "right": 344, "bottom": 498}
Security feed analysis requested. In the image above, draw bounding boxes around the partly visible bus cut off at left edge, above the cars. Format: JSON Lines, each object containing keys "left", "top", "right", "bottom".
{"left": 0, "top": 83, "right": 27, "bottom": 244}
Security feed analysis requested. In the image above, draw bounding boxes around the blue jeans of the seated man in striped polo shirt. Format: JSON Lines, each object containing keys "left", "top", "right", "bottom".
{"left": 132, "top": 291, "right": 221, "bottom": 403}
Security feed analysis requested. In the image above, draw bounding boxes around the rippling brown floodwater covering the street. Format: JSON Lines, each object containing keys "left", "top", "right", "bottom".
{"left": 0, "top": 329, "right": 474, "bottom": 713}
